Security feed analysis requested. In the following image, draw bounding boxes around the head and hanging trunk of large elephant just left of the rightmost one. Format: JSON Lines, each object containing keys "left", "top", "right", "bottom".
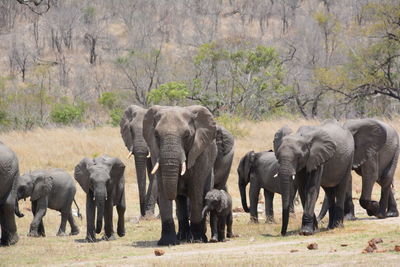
{"left": 274, "top": 126, "right": 336, "bottom": 235}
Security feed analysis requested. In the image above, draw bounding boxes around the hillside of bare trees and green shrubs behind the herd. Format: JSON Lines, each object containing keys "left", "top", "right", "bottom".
{"left": 0, "top": 0, "right": 400, "bottom": 130}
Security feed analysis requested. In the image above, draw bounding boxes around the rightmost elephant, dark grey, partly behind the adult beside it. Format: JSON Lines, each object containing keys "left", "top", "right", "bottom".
{"left": 321, "top": 119, "right": 399, "bottom": 222}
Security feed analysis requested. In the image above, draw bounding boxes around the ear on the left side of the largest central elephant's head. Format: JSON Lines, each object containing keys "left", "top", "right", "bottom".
{"left": 143, "top": 105, "right": 162, "bottom": 166}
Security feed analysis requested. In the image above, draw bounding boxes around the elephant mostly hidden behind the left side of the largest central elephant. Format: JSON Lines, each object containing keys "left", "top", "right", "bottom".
{"left": 120, "top": 105, "right": 158, "bottom": 217}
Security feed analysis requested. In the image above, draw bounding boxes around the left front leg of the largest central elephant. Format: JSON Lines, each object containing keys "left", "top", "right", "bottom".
{"left": 157, "top": 175, "right": 179, "bottom": 246}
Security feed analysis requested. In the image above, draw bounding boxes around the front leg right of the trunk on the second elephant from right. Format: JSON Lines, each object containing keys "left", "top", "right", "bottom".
{"left": 300, "top": 167, "right": 323, "bottom": 235}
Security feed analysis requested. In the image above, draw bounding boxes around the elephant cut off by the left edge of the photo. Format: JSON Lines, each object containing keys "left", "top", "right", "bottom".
{"left": 0, "top": 142, "right": 19, "bottom": 246}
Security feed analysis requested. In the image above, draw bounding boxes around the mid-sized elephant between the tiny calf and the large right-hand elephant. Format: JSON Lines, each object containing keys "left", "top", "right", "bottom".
{"left": 237, "top": 150, "right": 297, "bottom": 223}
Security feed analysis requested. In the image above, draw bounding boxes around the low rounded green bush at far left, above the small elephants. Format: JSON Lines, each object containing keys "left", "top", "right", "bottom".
{"left": 50, "top": 102, "right": 85, "bottom": 125}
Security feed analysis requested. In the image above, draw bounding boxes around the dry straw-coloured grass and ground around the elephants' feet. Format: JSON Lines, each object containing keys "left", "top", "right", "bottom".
{"left": 0, "top": 119, "right": 400, "bottom": 266}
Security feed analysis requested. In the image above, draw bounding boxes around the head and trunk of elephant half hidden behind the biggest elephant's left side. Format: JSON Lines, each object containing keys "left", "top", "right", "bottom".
{"left": 120, "top": 105, "right": 149, "bottom": 216}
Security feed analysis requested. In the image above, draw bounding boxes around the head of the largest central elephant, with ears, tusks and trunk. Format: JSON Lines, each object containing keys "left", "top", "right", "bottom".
{"left": 143, "top": 106, "right": 216, "bottom": 200}
